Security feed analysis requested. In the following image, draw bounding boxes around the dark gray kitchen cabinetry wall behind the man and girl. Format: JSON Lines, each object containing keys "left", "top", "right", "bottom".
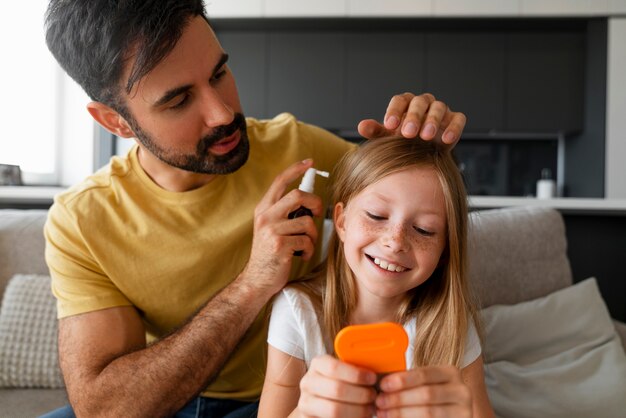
{"left": 212, "top": 18, "right": 607, "bottom": 197}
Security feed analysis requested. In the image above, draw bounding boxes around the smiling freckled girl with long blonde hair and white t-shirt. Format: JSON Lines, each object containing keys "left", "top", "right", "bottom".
{"left": 259, "top": 138, "right": 493, "bottom": 418}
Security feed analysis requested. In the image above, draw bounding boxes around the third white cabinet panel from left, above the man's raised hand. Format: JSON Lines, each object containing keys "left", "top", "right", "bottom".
{"left": 348, "top": 0, "right": 428, "bottom": 17}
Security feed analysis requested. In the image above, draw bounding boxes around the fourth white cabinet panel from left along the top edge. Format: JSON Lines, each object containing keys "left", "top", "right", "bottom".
{"left": 433, "top": 0, "right": 519, "bottom": 17}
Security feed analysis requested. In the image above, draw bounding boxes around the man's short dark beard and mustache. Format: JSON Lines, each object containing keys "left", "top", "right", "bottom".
{"left": 126, "top": 113, "right": 250, "bottom": 174}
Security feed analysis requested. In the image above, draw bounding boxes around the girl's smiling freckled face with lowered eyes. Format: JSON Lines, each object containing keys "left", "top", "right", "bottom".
{"left": 335, "top": 166, "right": 447, "bottom": 310}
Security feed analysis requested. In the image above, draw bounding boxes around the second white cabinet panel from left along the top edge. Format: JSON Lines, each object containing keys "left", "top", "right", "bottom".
{"left": 264, "top": 0, "right": 348, "bottom": 17}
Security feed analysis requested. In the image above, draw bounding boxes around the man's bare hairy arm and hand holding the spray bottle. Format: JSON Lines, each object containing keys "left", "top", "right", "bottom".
{"left": 59, "top": 161, "right": 322, "bottom": 417}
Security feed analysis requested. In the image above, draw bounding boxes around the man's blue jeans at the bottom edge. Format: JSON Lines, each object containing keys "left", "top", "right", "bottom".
{"left": 39, "top": 396, "right": 259, "bottom": 418}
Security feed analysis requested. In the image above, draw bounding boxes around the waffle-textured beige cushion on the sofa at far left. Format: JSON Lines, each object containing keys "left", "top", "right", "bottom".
{"left": 0, "top": 275, "right": 64, "bottom": 388}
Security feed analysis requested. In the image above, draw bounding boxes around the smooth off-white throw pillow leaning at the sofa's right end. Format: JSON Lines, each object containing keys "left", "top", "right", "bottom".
{"left": 482, "top": 278, "right": 626, "bottom": 418}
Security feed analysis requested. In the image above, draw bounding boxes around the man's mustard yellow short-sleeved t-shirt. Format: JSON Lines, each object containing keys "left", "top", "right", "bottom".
{"left": 45, "top": 114, "right": 353, "bottom": 400}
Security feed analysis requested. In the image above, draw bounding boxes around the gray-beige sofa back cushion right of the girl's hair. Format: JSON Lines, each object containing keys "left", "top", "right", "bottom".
{"left": 468, "top": 207, "right": 572, "bottom": 307}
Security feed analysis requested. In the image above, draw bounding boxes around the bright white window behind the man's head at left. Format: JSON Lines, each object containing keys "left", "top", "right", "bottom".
{"left": 0, "top": 0, "right": 94, "bottom": 185}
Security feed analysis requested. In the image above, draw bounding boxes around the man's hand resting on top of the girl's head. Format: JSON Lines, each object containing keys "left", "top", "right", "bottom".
{"left": 358, "top": 93, "right": 466, "bottom": 146}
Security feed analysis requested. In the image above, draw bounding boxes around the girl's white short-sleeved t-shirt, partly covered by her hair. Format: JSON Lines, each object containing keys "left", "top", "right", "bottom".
{"left": 267, "top": 288, "right": 482, "bottom": 369}
